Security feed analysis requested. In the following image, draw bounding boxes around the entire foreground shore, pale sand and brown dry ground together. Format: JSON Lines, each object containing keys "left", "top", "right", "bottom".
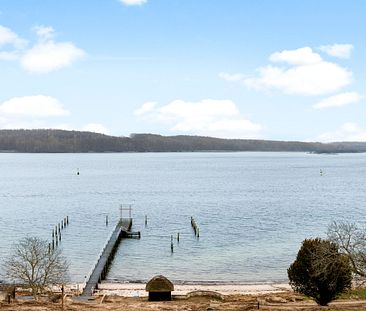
{"left": 0, "top": 282, "right": 366, "bottom": 311}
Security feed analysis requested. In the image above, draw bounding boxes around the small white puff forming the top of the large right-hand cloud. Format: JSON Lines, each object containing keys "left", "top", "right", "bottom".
{"left": 269, "top": 47, "right": 322, "bottom": 65}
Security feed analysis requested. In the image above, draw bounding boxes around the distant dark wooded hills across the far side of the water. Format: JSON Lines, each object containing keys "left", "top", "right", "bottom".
{"left": 0, "top": 129, "right": 366, "bottom": 153}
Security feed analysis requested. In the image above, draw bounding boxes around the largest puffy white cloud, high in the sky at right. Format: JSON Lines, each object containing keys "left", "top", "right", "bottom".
{"left": 221, "top": 47, "right": 352, "bottom": 96}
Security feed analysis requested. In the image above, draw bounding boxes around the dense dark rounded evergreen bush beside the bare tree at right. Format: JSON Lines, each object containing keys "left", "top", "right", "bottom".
{"left": 287, "top": 238, "right": 352, "bottom": 306}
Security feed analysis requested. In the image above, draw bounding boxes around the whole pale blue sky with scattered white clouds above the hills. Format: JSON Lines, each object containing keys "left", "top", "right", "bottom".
{"left": 0, "top": 0, "right": 366, "bottom": 141}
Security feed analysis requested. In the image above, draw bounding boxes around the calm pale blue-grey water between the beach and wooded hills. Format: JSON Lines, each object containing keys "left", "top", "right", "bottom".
{"left": 0, "top": 153, "right": 366, "bottom": 282}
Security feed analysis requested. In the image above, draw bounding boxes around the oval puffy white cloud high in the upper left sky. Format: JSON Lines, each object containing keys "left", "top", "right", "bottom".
{"left": 21, "top": 41, "right": 85, "bottom": 73}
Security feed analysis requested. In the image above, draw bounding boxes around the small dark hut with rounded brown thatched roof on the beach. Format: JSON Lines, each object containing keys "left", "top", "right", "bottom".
{"left": 146, "top": 275, "right": 174, "bottom": 301}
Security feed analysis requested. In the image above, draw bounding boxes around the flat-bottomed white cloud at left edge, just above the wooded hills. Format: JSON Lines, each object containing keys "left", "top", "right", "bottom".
{"left": 0, "top": 95, "right": 69, "bottom": 118}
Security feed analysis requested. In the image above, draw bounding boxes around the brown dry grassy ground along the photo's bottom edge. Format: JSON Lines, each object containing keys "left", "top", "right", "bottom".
{"left": 0, "top": 292, "right": 366, "bottom": 311}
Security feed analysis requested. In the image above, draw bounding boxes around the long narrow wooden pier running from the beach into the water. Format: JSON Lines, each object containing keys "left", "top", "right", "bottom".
{"left": 81, "top": 218, "right": 134, "bottom": 297}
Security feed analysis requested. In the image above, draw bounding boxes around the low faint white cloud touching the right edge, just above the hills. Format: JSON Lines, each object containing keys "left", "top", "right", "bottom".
{"left": 312, "top": 122, "right": 366, "bottom": 142}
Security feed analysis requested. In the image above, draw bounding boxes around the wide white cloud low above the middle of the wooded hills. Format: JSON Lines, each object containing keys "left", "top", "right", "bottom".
{"left": 135, "top": 99, "right": 262, "bottom": 138}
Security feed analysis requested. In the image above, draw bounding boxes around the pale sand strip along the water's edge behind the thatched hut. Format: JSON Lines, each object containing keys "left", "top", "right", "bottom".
{"left": 98, "top": 281, "right": 292, "bottom": 298}
